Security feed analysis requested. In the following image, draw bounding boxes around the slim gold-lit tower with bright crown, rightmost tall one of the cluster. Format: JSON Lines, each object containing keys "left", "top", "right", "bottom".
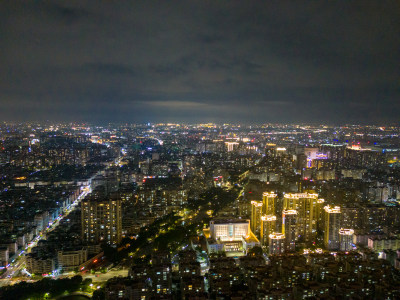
{"left": 324, "top": 205, "right": 340, "bottom": 250}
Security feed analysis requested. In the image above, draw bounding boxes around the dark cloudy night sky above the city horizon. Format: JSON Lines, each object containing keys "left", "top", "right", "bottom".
{"left": 0, "top": 0, "right": 400, "bottom": 124}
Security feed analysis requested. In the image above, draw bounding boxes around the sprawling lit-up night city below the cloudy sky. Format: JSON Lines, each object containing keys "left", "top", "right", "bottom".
{"left": 0, "top": 122, "right": 400, "bottom": 300}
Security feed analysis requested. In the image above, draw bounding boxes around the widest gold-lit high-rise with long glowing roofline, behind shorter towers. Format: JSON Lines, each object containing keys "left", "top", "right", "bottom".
{"left": 283, "top": 193, "right": 319, "bottom": 242}
